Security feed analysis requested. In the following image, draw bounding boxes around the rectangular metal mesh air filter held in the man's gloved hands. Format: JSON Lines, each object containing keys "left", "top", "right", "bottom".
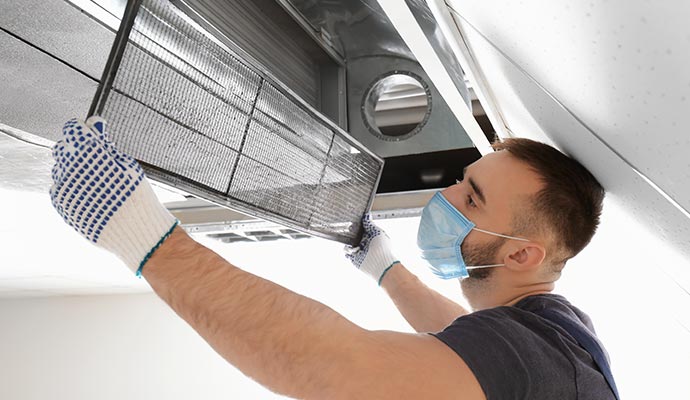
{"left": 90, "top": 0, "right": 383, "bottom": 244}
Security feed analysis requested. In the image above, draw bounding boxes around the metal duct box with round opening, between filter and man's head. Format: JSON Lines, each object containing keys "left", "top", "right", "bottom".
{"left": 280, "top": 0, "right": 479, "bottom": 193}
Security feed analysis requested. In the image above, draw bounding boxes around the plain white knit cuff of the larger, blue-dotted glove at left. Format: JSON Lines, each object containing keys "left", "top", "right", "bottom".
{"left": 96, "top": 179, "right": 178, "bottom": 276}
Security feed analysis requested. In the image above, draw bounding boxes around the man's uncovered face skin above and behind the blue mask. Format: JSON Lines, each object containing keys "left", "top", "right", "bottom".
{"left": 442, "top": 151, "right": 541, "bottom": 289}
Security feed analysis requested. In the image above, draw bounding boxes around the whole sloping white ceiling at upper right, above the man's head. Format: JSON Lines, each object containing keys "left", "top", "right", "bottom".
{"left": 436, "top": 0, "right": 690, "bottom": 260}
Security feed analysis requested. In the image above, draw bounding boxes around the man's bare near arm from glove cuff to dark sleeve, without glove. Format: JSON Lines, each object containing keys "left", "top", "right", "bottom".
{"left": 142, "top": 228, "right": 485, "bottom": 399}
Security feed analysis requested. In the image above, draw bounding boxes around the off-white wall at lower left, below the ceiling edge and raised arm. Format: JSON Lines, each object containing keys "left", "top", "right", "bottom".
{"left": 0, "top": 294, "right": 278, "bottom": 400}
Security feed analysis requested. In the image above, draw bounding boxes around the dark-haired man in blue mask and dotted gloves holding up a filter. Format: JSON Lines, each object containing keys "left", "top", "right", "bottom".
{"left": 51, "top": 118, "right": 614, "bottom": 399}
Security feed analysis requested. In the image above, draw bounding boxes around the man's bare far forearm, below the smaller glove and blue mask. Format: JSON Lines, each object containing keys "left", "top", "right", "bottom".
{"left": 381, "top": 264, "right": 468, "bottom": 332}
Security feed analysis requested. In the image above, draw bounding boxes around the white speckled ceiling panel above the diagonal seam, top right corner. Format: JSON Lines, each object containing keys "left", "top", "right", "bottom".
{"left": 447, "top": 0, "right": 690, "bottom": 219}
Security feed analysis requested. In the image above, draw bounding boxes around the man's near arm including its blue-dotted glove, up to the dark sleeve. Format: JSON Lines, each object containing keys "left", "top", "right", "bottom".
{"left": 50, "top": 121, "right": 483, "bottom": 399}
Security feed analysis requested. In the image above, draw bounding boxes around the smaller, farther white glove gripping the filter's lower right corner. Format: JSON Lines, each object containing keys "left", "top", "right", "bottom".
{"left": 345, "top": 214, "right": 400, "bottom": 286}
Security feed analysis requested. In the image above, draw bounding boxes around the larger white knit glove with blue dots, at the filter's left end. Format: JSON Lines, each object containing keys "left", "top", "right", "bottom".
{"left": 50, "top": 117, "right": 178, "bottom": 276}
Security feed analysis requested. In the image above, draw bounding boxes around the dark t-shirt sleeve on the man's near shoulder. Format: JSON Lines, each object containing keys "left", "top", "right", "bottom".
{"left": 432, "top": 307, "right": 576, "bottom": 400}
